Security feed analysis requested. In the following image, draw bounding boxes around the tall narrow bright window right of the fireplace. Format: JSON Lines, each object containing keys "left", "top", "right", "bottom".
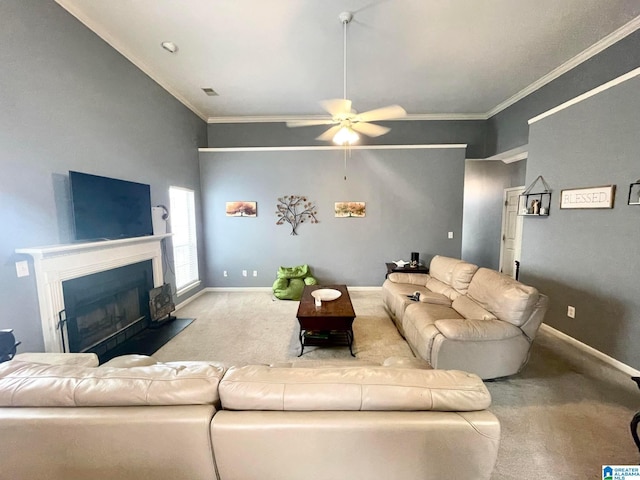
{"left": 169, "top": 187, "right": 200, "bottom": 293}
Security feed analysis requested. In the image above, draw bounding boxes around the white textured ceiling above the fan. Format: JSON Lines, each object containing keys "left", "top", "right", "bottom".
{"left": 57, "top": 0, "right": 640, "bottom": 121}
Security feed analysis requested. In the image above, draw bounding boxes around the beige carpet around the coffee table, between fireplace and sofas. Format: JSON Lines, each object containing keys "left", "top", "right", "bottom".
{"left": 154, "top": 292, "right": 413, "bottom": 365}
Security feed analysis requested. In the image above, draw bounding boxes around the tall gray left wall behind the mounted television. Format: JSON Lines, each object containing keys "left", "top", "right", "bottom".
{"left": 0, "top": 0, "right": 206, "bottom": 351}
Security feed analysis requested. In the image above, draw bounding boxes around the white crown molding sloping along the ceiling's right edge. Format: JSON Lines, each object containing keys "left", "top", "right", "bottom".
{"left": 486, "top": 15, "right": 640, "bottom": 118}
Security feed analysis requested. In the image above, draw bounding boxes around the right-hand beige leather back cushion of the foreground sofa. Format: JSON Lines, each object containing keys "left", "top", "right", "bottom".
{"left": 219, "top": 365, "right": 491, "bottom": 411}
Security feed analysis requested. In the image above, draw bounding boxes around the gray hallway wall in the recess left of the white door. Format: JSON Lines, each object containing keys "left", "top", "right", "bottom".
{"left": 462, "top": 160, "right": 527, "bottom": 270}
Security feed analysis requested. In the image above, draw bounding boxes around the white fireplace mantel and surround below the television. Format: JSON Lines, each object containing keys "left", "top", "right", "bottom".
{"left": 16, "top": 234, "right": 171, "bottom": 352}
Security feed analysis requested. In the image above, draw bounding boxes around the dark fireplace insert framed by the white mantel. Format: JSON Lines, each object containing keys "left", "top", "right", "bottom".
{"left": 62, "top": 260, "right": 153, "bottom": 356}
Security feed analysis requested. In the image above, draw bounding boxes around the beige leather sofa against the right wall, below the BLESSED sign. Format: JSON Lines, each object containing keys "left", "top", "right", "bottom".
{"left": 382, "top": 255, "right": 548, "bottom": 380}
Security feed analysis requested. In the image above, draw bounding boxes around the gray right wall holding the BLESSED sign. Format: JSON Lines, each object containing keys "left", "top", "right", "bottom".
{"left": 521, "top": 77, "right": 640, "bottom": 369}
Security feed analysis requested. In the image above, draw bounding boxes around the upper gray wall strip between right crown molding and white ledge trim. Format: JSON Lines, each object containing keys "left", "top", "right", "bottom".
{"left": 484, "top": 30, "right": 640, "bottom": 158}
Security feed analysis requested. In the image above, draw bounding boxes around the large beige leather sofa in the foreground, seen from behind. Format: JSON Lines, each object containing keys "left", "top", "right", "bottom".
{"left": 0, "top": 357, "right": 500, "bottom": 480}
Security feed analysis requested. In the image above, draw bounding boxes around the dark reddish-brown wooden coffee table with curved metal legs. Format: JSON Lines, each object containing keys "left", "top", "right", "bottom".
{"left": 296, "top": 285, "right": 356, "bottom": 357}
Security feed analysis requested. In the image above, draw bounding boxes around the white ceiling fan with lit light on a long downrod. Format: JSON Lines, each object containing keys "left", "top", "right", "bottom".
{"left": 287, "top": 12, "right": 407, "bottom": 145}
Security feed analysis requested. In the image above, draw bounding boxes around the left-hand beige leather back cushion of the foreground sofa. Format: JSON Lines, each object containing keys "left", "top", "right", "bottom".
{"left": 0, "top": 360, "right": 225, "bottom": 407}
